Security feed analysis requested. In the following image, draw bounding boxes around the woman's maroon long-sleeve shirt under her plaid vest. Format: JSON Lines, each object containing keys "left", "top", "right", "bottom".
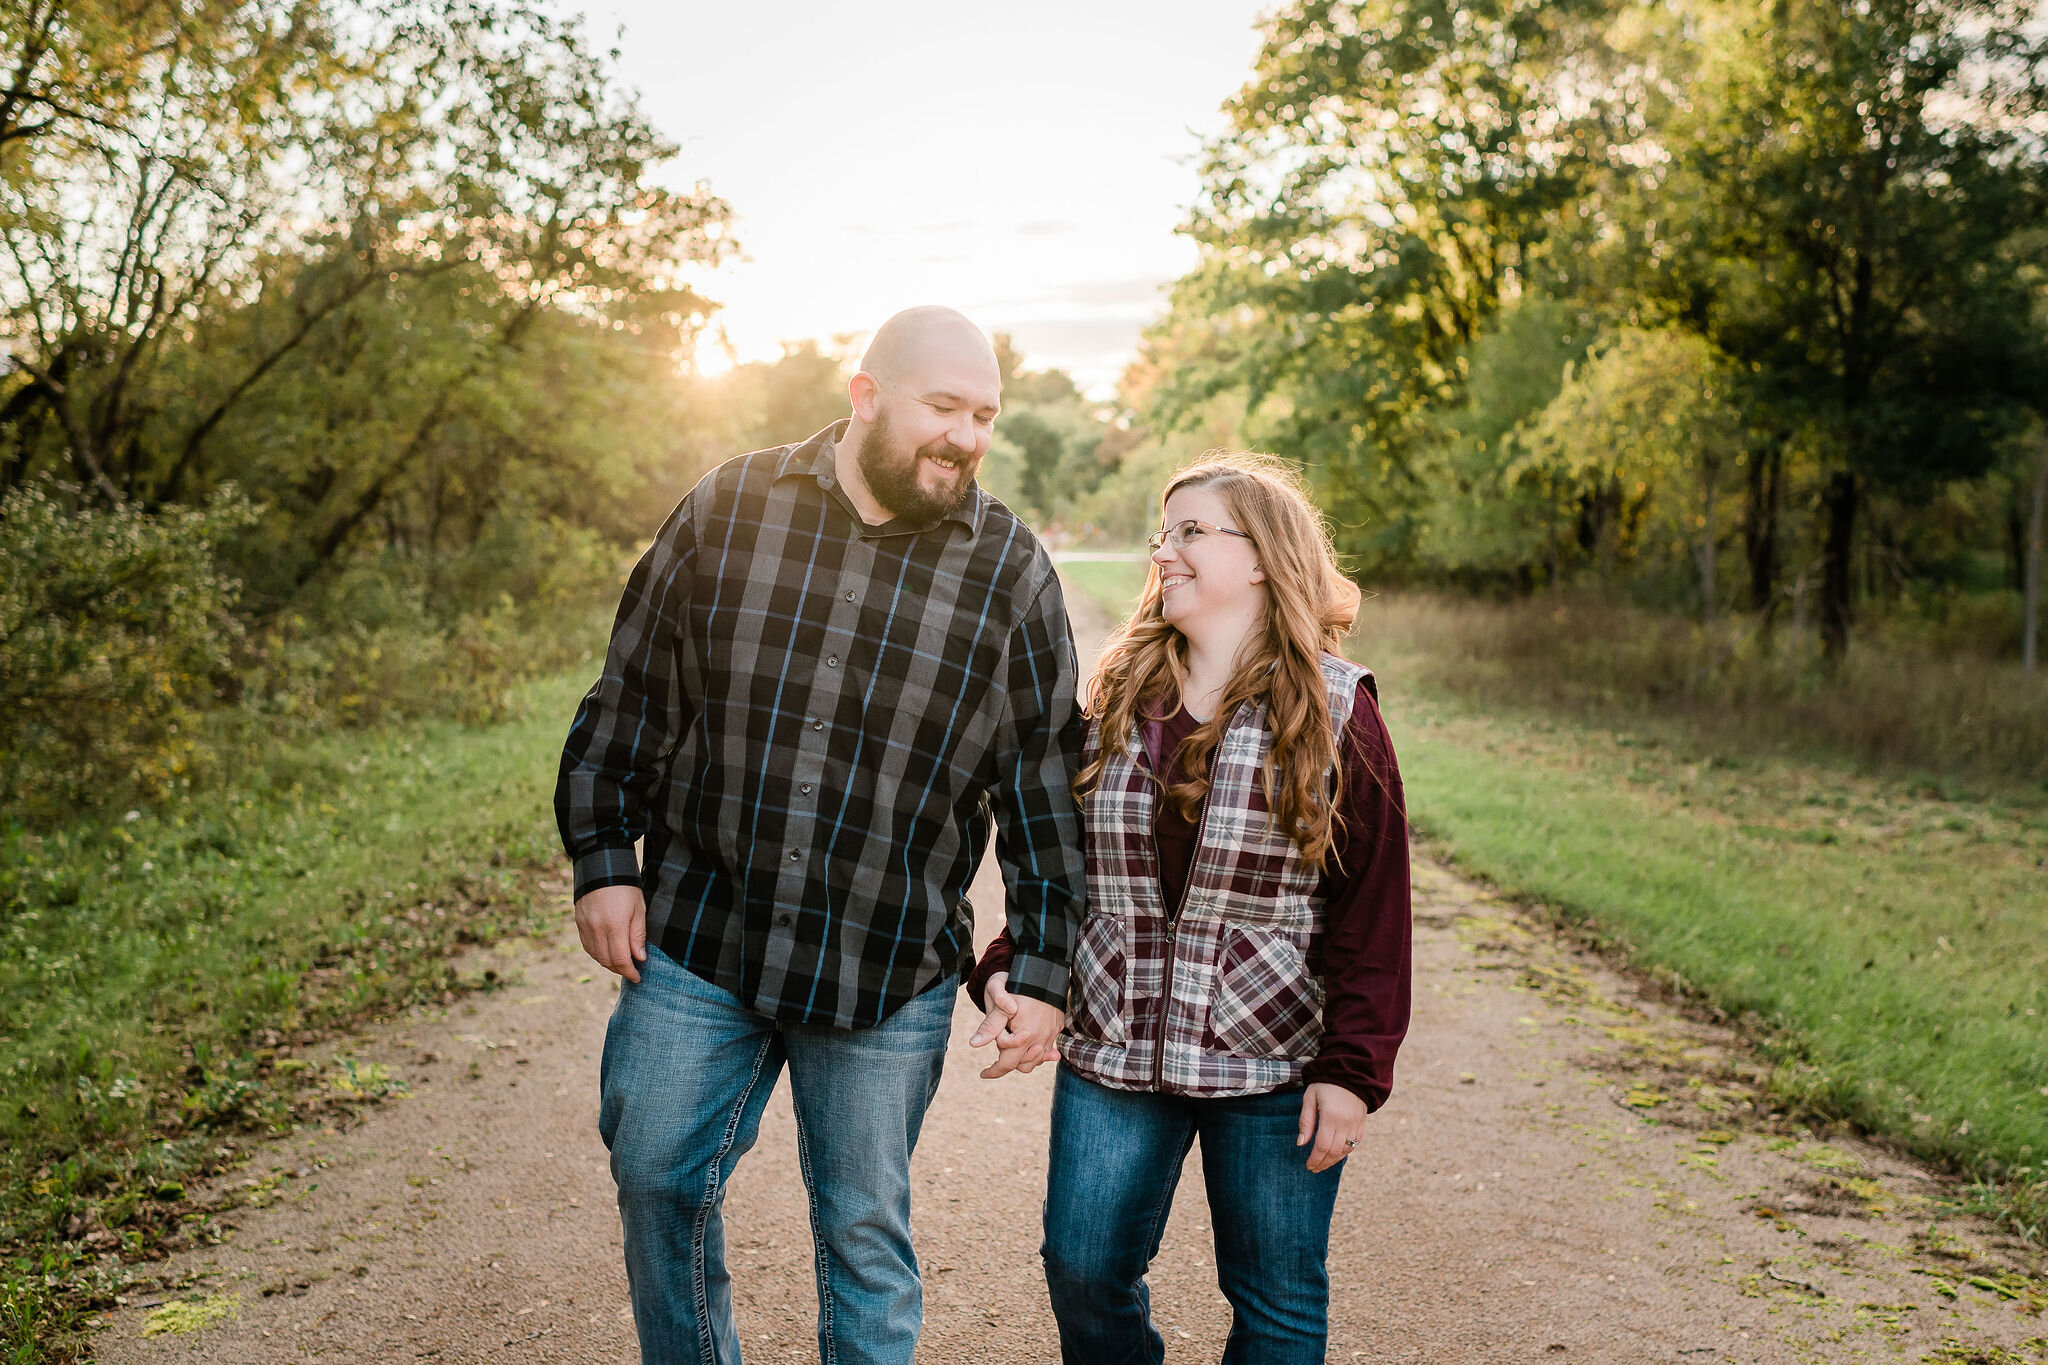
{"left": 967, "top": 688, "right": 1409, "bottom": 1109}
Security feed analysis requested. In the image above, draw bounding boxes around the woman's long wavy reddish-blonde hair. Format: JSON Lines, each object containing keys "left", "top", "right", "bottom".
{"left": 1075, "top": 450, "right": 1360, "bottom": 866}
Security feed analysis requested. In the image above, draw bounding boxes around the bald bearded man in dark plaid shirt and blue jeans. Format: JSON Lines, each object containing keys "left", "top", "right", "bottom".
{"left": 555, "top": 307, "right": 1083, "bottom": 1365}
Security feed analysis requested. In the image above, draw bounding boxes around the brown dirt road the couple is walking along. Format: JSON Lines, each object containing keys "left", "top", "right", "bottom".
{"left": 100, "top": 589, "right": 2048, "bottom": 1365}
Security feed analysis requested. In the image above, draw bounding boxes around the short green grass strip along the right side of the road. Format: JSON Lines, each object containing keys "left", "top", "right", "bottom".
{"left": 1063, "top": 563, "right": 2048, "bottom": 1240}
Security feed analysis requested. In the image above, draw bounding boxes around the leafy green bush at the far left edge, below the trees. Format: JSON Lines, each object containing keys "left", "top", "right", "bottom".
{"left": 0, "top": 485, "right": 254, "bottom": 823}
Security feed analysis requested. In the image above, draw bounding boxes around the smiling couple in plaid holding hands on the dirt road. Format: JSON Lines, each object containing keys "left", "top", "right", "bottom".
{"left": 555, "top": 309, "right": 1409, "bottom": 1365}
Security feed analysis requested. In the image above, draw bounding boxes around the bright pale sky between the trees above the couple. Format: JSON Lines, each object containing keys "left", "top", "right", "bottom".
{"left": 571, "top": 0, "right": 1270, "bottom": 393}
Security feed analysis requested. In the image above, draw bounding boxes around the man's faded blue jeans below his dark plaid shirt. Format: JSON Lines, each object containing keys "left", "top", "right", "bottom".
{"left": 598, "top": 943, "right": 958, "bottom": 1365}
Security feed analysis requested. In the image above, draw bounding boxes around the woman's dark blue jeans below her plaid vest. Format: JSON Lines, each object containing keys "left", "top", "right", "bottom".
{"left": 1040, "top": 1066, "right": 1343, "bottom": 1365}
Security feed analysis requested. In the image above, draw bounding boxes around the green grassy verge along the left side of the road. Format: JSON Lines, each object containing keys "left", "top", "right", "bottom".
{"left": 0, "top": 667, "right": 588, "bottom": 1361}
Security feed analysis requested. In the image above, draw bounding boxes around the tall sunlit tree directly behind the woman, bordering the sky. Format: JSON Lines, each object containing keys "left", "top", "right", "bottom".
{"left": 1151, "top": 0, "right": 1634, "bottom": 563}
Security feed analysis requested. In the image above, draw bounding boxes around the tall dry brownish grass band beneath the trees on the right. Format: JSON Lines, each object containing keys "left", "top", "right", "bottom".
{"left": 1354, "top": 591, "right": 2048, "bottom": 786}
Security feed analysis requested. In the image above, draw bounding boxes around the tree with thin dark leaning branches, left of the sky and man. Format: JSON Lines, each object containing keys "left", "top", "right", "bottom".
{"left": 0, "top": 0, "right": 725, "bottom": 581}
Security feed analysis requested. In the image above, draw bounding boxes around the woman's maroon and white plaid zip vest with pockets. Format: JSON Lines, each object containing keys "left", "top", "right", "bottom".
{"left": 1059, "top": 655, "right": 1372, "bottom": 1099}
